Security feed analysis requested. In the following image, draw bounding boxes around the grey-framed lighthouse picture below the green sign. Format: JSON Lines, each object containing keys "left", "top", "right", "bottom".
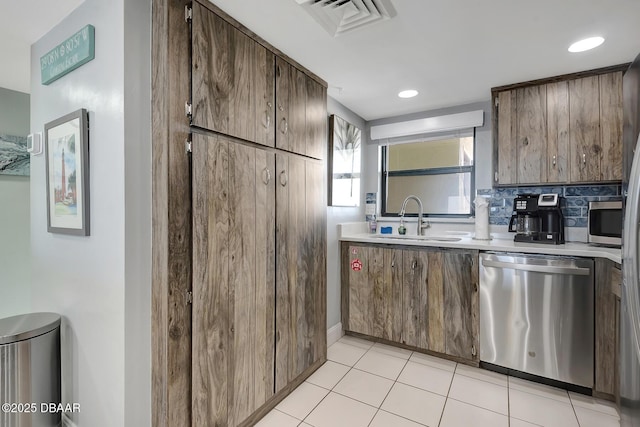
{"left": 44, "top": 108, "right": 89, "bottom": 236}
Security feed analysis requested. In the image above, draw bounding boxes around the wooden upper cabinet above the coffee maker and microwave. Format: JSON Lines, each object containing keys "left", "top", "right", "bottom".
{"left": 493, "top": 66, "right": 622, "bottom": 185}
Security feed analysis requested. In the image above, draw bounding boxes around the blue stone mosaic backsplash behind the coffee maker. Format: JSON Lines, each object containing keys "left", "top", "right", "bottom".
{"left": 477, "top": 185, "right": 622, "bottom": 227}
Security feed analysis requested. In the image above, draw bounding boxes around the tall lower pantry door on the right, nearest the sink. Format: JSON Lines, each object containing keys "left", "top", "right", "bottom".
{"left": 276, "top": 155, "right": 326, "bottom": 391}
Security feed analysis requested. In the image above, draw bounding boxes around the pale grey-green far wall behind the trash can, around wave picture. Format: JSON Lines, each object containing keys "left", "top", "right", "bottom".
{"left": 0, "top": 88, "right": 31, "bottom": 319}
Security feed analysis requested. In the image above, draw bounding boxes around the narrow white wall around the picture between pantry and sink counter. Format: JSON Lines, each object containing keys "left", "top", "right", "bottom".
{"left": 327, "top": 97, "right": 364, "bottom": 328}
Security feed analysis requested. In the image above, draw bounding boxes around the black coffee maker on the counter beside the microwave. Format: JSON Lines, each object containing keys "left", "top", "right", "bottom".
{"left": 509, "top": 193, "right": 564, "bottom": 245}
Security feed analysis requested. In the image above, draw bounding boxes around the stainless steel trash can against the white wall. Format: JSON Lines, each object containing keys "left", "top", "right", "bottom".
{"left": 0, "top": 313, "right": 62, "bottom": 427}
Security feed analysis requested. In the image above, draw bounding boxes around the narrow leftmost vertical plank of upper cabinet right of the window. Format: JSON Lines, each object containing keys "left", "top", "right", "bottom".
{"left": 494, "top": 90, "right": 518, "bottom": 184}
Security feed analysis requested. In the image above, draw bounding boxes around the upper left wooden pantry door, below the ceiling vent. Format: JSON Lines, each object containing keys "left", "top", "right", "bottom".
{"left": 192, "top": 2, "right": 275, "bottom": 147}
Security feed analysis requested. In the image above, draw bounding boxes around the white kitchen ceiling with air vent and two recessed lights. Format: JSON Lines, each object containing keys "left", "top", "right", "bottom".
{"left": 212, "top": 0, "right": 640, "bottom": 120}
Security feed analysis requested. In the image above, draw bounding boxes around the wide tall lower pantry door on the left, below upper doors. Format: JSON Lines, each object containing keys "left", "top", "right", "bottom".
{"left": 192, "top": 134, "right": 275, "bottom": 426}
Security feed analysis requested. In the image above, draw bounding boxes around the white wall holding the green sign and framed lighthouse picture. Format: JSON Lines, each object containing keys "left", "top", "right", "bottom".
{"left": 31, "top": 0, "right": 151, "bottom": 427}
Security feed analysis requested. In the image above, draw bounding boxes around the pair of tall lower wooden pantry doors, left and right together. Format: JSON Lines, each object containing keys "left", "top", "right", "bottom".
{"left": 192, "top": 134, "right": 326, "bottom": 426}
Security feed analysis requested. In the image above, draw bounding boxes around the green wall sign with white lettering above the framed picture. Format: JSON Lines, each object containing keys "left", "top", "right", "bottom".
{"left": 40, "top": 25, "right": 96, "bottom": 85}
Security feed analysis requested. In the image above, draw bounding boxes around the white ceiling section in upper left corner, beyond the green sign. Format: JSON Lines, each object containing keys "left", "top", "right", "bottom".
{"left": 0, "top": 0, "right": 84, "bottom": 93}
